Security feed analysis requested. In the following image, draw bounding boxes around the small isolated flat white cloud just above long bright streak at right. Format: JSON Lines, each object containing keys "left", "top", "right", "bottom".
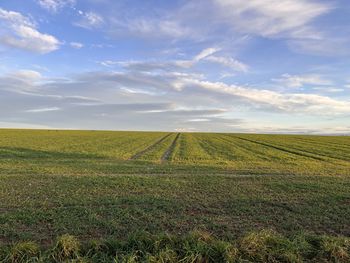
{"left": 273, "top": 74, "right": 333, "bottom": 88}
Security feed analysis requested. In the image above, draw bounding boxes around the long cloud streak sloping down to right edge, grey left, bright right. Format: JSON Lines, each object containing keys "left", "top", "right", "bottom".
{"left": 72, "top": 71, "right": 350, "bottom": 116}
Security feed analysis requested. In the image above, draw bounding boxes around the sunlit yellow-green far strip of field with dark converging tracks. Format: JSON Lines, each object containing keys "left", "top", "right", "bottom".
{"left": 0, "top": 130, "right": 350, "bottom": 174}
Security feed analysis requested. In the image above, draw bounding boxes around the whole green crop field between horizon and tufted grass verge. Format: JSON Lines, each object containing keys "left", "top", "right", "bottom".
{"left": 0, "top": 130, "right": 350, "bottom": 260}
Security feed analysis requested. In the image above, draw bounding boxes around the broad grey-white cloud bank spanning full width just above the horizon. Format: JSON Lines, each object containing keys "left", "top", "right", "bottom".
{"left": 0, "top": 70, "right": 350, "bottom": 132}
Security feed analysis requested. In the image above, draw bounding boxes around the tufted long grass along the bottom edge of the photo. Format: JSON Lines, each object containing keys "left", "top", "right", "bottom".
{"left": 0, "top": 231, "right": 350, "bottom": 263}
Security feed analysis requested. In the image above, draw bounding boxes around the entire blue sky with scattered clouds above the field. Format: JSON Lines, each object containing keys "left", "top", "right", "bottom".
{"left": 0, "top": 0, "right": 350, "bottom": 134}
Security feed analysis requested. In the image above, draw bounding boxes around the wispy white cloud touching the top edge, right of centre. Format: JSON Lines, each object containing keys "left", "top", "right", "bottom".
{"left": 214, "top": 0, "right": 332, "bottom": 38}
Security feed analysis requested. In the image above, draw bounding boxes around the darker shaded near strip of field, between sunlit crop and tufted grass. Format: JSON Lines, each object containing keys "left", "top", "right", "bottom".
{"left": 0, "top": 175, "right": 350, "bottom": 244}
